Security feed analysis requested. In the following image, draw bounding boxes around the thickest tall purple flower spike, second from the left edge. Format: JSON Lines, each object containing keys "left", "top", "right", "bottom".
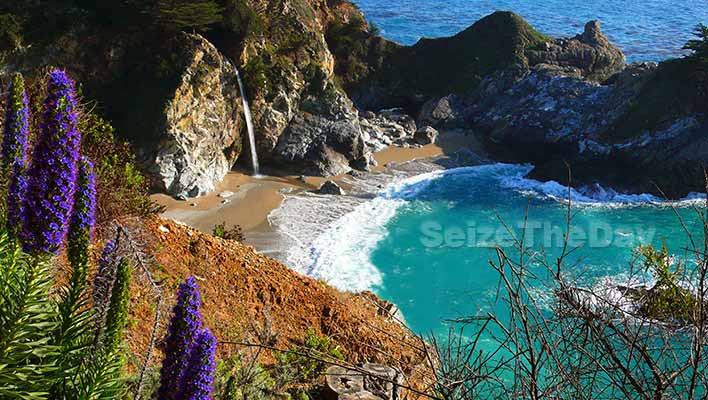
{"left": 22, "top": 69, "right": 81, "bottom": 253}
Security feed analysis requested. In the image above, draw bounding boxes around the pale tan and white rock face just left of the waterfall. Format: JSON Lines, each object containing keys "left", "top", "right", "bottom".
{"left": 148, "top": 34, "right": 243, "bottom": 197}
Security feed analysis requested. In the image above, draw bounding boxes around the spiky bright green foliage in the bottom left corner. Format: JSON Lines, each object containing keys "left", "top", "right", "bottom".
{"left": 0, "top": 231, "right": 129, "bottom": 399}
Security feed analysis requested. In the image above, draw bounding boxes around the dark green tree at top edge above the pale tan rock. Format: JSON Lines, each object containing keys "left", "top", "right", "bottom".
{"left": 157, "top": 0, "right": 224, "bottom": 30}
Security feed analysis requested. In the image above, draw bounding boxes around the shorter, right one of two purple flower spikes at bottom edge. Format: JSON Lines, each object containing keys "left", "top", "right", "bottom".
{"left": 182, "top": 329, "right": 216, "bottom": 400}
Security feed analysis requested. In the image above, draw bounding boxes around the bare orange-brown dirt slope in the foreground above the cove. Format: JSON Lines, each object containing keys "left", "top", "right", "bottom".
{"left": 128, "top": 219, "right": 427, "bottom": 376}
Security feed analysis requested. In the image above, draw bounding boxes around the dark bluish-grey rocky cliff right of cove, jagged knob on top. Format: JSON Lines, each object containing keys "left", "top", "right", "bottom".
{"left": 420, "top": 22, "right": 708, "bottom": 197}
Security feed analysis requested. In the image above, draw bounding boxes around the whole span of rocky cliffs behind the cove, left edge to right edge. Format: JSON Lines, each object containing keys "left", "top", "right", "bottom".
{"left": 2, "top": 0, "right": 708, "bottom": 198}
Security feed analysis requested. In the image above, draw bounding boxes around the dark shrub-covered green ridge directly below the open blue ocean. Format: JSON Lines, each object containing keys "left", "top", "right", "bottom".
{"left": 326, "top": 12, "right": 550, "bottom": 112}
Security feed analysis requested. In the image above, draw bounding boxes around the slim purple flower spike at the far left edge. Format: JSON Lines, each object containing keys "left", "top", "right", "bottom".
{"left": 2, "top": 74, "right": 29, "bottom": 233}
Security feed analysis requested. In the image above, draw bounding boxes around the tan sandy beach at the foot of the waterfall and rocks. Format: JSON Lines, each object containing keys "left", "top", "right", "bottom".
{"left": 151, "top": 132, "right": 481, "bottom": 238}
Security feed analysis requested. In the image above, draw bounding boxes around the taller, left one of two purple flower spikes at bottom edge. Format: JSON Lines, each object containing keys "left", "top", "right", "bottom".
{"left": 157, "top": 277, "right": 202, "bottom": 400}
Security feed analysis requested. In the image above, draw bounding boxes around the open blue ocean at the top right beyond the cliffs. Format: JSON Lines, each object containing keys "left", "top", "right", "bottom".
{"left": 355, "top": 0, "right": 708, "bottom": 62}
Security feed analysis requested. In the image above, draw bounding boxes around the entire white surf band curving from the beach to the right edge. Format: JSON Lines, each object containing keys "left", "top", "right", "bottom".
{"left": 269, "top": 161, "right": 705, "bottom": 291}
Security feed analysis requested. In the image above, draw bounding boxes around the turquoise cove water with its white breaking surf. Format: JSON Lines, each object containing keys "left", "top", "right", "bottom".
{"left": 308, "top": 164, "right": 703, "bottom": 333}
